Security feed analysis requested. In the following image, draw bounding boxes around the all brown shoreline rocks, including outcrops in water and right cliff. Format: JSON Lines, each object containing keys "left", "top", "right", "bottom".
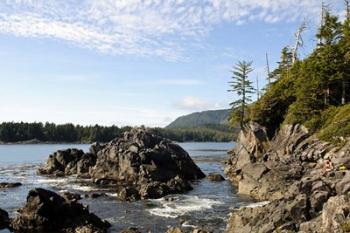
{"left": 0, "top": 123, "right": 350, "bottom": 233}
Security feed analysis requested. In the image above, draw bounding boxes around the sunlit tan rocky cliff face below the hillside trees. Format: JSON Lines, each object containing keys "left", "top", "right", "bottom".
{"left": 225, "top": 123, "right": 350, "bottom": 233}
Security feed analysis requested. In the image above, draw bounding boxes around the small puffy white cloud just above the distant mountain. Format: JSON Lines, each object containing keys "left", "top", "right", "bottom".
{"left": 175, "top": 96, "right": 220, "bottom": 111}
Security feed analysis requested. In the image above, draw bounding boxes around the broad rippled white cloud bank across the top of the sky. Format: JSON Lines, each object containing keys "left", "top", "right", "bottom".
{"left": 0, "top": 0, "right": 320, "bottom": 60}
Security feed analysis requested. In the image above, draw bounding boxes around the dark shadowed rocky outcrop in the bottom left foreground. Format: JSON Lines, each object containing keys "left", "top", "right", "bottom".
{"left": 11, "top": 188, "right": 110, "bottom": 233}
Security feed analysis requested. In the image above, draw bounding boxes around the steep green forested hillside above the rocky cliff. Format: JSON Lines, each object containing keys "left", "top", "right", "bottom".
{"left": 237, "top": 11, "right": 350, "bottom": 142}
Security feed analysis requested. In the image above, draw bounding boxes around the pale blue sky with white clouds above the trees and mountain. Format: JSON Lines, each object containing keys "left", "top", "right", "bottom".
{"left": 0, "top": 0, "right": 343, "bottom": 126}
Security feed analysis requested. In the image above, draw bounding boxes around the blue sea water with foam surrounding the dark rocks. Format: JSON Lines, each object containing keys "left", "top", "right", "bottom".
{"left": 0, "top": 143, "right": 252, "bottom": 233}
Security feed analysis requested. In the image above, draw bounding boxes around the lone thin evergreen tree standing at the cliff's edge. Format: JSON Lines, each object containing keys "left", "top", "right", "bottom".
{"left": 228, "top": 61, "right": 254, "bottom": 128}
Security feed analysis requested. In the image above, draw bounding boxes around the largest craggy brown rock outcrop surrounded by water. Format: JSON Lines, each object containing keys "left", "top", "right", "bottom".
{"left": 39, "top": 128, "right": 205, "bottom": 200}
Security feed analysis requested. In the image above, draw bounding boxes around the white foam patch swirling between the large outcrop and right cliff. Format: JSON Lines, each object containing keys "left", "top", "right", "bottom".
{"left": 148, "top": 195, "right": 223, "bottom": 218}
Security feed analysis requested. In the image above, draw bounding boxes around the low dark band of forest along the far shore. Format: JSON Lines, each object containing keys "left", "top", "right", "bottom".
{"left": 0, "top": 122, "right": 234, "bottom": 143}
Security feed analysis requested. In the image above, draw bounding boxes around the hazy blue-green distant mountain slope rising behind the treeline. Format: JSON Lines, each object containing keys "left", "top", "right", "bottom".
{"left": 166, "top": 109, "right": 230, "bottom": 128}
